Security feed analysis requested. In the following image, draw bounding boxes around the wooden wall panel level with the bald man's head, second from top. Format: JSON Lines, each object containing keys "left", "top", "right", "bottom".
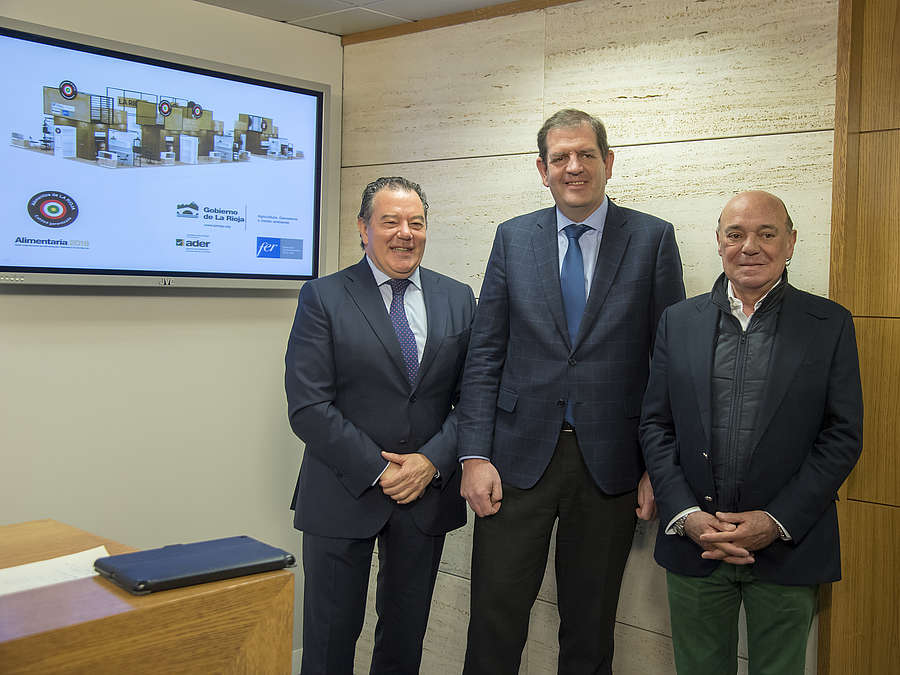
{"left": 835, "top": 130, "right": 900, "bottom": 317}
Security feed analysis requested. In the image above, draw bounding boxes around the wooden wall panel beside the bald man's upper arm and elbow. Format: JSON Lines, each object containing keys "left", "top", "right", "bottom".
{"left": 847, "top": 318, "right": 900, "bottom": 506}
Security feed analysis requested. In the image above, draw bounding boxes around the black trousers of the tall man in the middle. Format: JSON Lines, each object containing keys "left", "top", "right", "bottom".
{"left": 463, "top": 431, "right": 637, "bottom": 675}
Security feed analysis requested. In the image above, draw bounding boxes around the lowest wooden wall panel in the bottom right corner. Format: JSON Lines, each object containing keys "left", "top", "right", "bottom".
{"left": 819, "top": 500, "right": 900, "bottom": 675}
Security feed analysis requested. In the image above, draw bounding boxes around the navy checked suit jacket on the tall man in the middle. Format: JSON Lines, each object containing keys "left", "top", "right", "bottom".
{"left": 459, "top": 201, "right": 684, "bottom": 494}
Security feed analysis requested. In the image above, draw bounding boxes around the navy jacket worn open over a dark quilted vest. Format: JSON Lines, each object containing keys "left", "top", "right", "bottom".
{"left": 641, "top": 286, "right": 862, "bottom": 585}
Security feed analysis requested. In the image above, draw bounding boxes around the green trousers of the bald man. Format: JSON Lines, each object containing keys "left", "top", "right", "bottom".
{"left": 666, "top": 563, "right": 818, "bottom": 675}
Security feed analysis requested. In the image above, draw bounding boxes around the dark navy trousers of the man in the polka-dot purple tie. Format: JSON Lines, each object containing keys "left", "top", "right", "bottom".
{"left": 300, "top": 506, "right": 444, "bottom": 675}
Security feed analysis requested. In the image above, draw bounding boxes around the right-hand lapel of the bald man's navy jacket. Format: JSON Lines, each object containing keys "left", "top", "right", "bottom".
{"left": 750, "top": 286, "right": 817, "bottom": 457}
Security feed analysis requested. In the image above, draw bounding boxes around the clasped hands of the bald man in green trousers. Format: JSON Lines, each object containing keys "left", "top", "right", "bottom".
{"left": 684, "top": 511, "right": 778, "bottom": 565}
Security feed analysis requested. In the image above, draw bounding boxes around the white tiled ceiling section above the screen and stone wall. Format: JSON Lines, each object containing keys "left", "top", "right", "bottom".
{"left": 197, "top": 0, "right": 520, "bottom": 35}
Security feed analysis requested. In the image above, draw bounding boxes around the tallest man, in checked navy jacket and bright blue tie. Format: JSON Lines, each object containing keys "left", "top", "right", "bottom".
{"left": 459, "top": 110, "right": 684, "bottom": 675}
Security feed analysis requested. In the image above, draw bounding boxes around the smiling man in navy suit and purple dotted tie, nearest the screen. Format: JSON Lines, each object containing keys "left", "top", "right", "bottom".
{"left": 285, "top": 178, "right": 475, "bottom": 675}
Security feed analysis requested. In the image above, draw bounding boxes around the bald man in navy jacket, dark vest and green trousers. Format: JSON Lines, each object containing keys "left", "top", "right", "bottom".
{"left": 641, "top": 191, "right": 862, "bottom": 675}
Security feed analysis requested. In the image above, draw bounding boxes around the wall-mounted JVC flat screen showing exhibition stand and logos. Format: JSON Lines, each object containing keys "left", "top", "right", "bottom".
{"left": 0, "top": 26, "right": 327, "bottom": 287}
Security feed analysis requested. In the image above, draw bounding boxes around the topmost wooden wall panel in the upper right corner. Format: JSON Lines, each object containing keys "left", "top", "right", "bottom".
{"left": 860, "top": 0, "right": 900, "bottom": 131}
